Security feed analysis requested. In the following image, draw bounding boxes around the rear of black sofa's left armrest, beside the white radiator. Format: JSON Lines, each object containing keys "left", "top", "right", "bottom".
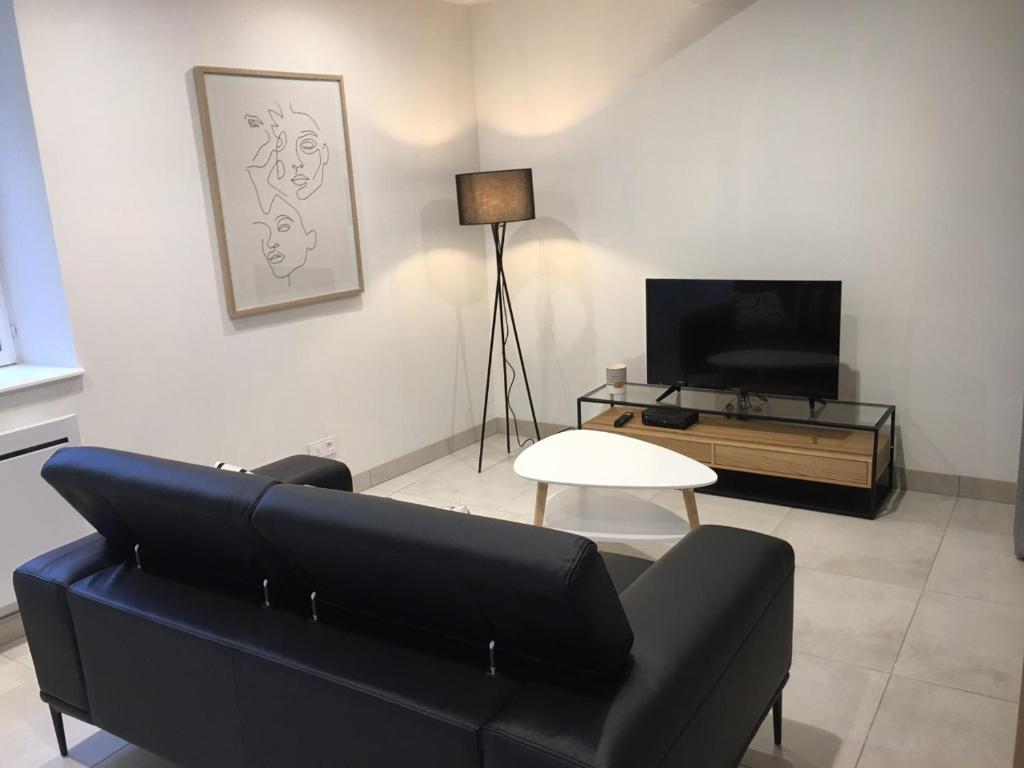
{"left": 14, "top": 534, "right": 129, "bottom": 712}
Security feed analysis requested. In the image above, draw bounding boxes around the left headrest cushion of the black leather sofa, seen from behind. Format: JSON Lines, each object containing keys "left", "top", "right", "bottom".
{"left": 42, "top": 447, "right": 283, "bottom": 596}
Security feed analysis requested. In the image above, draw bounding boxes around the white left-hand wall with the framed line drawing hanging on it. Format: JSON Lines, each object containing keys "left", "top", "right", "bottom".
{"left": 0, "top": 0, "right": 488, "bottom": 472}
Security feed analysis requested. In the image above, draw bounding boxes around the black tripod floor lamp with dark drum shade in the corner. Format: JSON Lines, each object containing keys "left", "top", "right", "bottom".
{"left": 455, "top": 168, "right": 541, "bottom": 472}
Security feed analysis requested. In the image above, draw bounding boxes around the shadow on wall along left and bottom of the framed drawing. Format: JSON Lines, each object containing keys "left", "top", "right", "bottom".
{"left": 184, "top": 70, "right": 366, "bottom": 336}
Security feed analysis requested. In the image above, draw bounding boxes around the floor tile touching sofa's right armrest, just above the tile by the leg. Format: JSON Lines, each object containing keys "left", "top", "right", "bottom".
{"left": 794, "top": 567, "right": 921, "bottom": 672}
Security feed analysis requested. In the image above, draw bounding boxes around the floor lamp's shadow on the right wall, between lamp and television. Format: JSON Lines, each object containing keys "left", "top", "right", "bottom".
{"left": 505, "top": 201, "right": 599, "bottom": 421}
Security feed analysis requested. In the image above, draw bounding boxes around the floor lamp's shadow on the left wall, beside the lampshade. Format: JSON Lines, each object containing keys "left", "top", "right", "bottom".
{"left": 420, "top": 199, "right": 486, "bottom": 442}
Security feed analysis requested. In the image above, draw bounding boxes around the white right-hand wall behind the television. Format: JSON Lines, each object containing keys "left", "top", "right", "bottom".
{"left": 473, "top": 0, "right": 1024, "bottom": 480}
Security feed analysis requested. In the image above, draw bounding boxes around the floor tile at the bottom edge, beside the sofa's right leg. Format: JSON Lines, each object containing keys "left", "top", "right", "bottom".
{"left": 742, "top": 653, "right": 889, "bottom": 768}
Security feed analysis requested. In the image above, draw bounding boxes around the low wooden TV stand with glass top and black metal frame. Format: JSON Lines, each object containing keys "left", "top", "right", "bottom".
{"left": 577, "top": 383, "right": 896, "bottom": 517}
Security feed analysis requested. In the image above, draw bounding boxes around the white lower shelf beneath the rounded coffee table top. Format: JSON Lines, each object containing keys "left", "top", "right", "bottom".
{"left": 544, "top": 487, "right": 690, "bottom": 542}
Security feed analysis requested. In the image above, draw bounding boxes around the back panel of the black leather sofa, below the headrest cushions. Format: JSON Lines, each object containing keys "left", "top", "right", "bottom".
{"left": 69, "top": 565, "right": 517, "bottom": 766}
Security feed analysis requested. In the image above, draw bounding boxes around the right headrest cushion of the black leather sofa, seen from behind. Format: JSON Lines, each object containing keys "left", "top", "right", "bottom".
{"left": 253, "top": 485, "right": 633, "bottom": 674}
